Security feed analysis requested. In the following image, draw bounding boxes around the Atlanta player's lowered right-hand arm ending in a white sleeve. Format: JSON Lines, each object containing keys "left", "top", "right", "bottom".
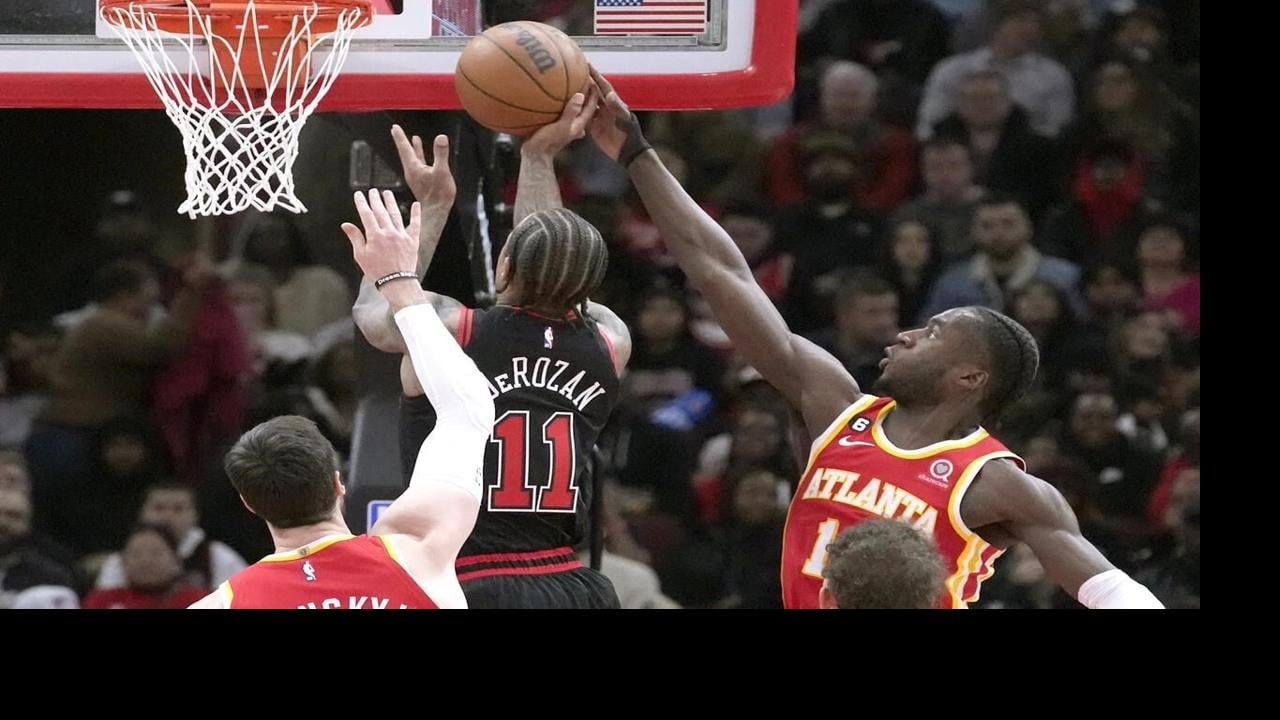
{"left": 960, "top": 461, "right": 1164, "bottom": 610}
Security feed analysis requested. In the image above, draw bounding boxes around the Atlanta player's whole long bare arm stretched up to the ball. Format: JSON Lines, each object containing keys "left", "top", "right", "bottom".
{"left": 590, "top": 69, "right": 861, "bottom": 433}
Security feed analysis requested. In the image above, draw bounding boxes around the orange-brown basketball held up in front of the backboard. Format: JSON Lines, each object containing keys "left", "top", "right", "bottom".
{"left": 453, "top": 20, "right": 590, "bottom": 136}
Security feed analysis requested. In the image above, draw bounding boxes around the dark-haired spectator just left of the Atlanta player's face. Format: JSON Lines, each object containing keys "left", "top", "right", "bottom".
{"left": 809, "top": 274, "right": 901, "bottom": 388}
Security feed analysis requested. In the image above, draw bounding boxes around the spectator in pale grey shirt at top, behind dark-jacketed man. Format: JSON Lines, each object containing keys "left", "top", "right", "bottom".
{"left": 916, "top": 0, "right": 1075, "bottom": 138}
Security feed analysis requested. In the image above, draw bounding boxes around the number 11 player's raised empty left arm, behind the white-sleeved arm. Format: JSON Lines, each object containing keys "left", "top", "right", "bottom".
{"left": 351, "top": 126, "right": 462, "bottom": 354}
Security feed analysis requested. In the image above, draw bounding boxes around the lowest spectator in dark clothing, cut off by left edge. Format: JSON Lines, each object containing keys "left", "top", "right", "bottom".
{"left": 0, "top": 488, "right": 76, "bottom": 609}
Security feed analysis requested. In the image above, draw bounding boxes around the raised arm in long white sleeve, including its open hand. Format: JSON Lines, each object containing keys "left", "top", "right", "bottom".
{"left": 342, "top": 191, "right": 494, "bottom": 558}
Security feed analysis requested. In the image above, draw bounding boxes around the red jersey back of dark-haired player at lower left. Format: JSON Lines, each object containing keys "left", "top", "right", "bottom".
{"left": 218, "top": 536, "right": 436, "bottom": 610}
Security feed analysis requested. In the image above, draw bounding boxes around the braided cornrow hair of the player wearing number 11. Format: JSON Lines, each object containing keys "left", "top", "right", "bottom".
{"left": 507, "top": 208, "right": 609, "bottom": 322}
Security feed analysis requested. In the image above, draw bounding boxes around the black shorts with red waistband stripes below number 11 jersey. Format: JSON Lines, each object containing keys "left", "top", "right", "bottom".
{"left": 457, "top": 547, "right": 621, "bottom": 610}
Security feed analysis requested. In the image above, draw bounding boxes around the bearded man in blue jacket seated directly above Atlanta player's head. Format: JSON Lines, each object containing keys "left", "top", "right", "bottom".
{"left": 919, "top": 195, "right": 1087, "bottom": 324}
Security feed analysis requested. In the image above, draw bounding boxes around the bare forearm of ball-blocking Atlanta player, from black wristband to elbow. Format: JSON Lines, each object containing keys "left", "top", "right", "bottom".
{"left": 627, "top": 150, "right": 750, "bottom": 283}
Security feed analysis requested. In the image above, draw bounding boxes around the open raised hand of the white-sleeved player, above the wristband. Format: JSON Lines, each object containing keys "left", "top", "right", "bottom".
{"left": 342, "top": 190, "right": 422, "bottom": 282}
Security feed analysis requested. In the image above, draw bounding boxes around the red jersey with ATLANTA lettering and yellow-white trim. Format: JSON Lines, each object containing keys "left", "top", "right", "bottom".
{"left": 782, "top": 395, "right": 1024, "bottom": 609}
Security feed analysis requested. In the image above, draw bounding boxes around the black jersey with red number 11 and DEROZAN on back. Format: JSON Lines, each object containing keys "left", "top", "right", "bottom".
{"left": 401, "top": 305, "right": 618, "bottom": 550}
